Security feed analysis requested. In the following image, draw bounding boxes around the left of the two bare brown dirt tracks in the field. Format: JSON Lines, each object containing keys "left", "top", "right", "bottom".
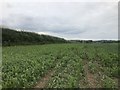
{"left": 34, "top": 70, "right": 53, "bottom": 88}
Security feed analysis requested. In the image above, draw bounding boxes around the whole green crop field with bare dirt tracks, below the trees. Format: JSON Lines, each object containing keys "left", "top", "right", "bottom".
{"left": 2, "top": 43, "right": 118, "bottom": 88}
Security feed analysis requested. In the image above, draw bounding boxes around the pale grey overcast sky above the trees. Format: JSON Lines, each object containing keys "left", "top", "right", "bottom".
{"left": 0, "top": 0, "right": 118, "bottom": 40}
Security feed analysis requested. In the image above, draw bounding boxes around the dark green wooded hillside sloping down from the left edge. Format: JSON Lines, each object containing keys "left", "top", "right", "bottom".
{"left": 2, "top": 28, "right": 67, "bottom": 46}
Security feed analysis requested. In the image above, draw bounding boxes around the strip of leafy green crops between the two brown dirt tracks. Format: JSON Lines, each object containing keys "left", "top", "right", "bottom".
{"left": 47, "top": 52, "right": 83, "bottom": 88}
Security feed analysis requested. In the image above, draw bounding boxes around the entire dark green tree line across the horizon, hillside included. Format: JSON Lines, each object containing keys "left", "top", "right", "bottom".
{"left": 0, "top": 28, "right": 120, "bottom": 46}
